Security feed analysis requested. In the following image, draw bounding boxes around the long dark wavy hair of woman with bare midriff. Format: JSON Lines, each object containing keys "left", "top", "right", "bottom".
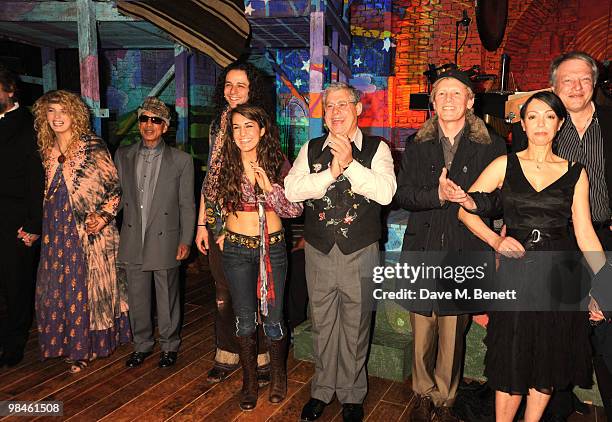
{"left": 217, "top": 104, "right": 285, "bottom": 212}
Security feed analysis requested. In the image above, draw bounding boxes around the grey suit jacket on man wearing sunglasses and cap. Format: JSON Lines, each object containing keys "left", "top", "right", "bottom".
{"left": 115, "top": 142, "right": 195, "bottom": 271}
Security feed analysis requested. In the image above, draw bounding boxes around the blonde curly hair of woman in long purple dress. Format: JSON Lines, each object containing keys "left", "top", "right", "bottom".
{"left": 32, "top": 90, "right": 92, "bottom": 156}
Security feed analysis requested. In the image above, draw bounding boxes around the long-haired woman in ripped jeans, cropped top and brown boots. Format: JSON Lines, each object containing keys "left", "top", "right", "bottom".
{"left": 216, "top": 104, "right": 302, "bottom": 410}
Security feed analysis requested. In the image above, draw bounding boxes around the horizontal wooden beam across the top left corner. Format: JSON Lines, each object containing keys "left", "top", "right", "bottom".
{"left": 0, "top": 1, "right": 135, "bottom": 22}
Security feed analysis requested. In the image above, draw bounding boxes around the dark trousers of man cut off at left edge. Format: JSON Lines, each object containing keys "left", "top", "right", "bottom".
{"left": 0, "top": 228, "right": 36, "bottom": 354}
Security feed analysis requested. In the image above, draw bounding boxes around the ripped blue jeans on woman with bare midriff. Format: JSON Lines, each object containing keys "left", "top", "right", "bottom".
{"left": 223, "top": 237, "right": 287, "bottom": 340}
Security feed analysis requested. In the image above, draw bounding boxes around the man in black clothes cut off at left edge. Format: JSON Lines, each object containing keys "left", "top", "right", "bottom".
{"left": 0, "top": 65, "right": 44, "bottom": 367}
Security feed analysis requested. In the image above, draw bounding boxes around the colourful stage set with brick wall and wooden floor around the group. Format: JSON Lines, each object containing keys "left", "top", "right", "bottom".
{"left": 0, "top": 0, "right": 612, "bottom": 421}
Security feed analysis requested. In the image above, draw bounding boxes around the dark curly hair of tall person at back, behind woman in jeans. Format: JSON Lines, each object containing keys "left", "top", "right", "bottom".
{"left": 213, "top": 60, "right": 274, "bottom": 126}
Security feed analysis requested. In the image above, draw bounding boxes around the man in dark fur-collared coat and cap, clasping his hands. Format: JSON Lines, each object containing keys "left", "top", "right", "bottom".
{"left": 395, "top": 70, "right": 506, "bottom": 422}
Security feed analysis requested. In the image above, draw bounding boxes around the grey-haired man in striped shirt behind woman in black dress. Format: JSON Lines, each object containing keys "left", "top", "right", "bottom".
{"left": 512, "top": 51, "right": 612, "bottom": 420}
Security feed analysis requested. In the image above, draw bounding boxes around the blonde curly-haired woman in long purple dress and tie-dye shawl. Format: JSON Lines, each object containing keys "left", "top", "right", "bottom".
{"left": 34, "top": 90, "right": 130, "bottom": 373}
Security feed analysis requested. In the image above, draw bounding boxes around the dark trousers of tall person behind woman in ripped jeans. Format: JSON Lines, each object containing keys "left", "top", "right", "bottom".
{"left": 208, "top": 230, "right": 268, "bottom": 365}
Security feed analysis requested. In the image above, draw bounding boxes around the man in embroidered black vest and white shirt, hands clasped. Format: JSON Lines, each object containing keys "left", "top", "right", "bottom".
{"left": 285, "top": 83, "right": 396, "bottom": 421}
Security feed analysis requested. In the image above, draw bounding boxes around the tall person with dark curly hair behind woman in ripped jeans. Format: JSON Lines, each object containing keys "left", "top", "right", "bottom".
{"left": 195, "top": 61, "right": 272, "bottom": 386}
